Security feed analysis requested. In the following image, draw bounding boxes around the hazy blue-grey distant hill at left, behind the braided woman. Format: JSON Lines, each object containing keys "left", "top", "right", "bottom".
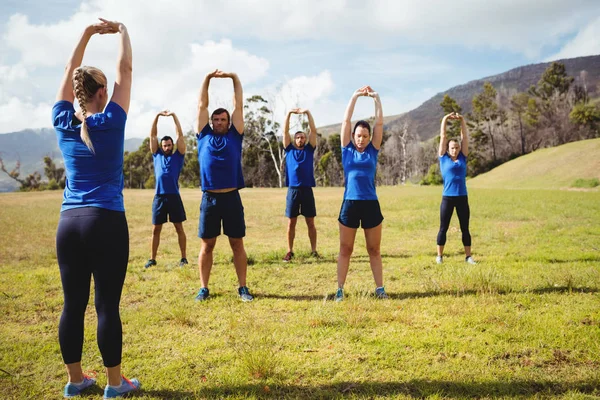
{"left": 0, "top": 128, "right": 143, "bottom": 192}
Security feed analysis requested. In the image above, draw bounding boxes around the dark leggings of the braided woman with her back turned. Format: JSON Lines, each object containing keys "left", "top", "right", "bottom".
{"left": 56, "top": 207, "right": 129, "bottom": 367}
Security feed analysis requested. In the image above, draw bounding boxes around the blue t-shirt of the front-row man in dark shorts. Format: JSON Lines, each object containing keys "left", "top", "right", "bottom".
{"left": 196, "top": 124, "right": 245, "bottom": 190}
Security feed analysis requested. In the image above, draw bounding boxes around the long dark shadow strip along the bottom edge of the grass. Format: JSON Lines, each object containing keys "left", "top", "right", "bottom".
{"left": 139, "top": 379, "right": 600, "bottom": 399}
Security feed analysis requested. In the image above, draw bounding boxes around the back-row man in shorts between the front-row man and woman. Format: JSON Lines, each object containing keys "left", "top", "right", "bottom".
{"left": 283, "top": 108, "right": 319, "bottom": 262}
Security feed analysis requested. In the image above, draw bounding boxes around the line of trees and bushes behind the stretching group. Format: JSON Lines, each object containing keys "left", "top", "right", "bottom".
{"left": 0, "top": 62, "right": 600, "bottom": 190}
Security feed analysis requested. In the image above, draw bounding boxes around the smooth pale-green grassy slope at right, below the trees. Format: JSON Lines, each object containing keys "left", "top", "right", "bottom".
{"left": 467, "top": 139, "right": 600, "bottom": 190}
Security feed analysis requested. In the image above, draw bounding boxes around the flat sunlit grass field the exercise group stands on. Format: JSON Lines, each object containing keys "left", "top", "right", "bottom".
{"left": 0, "top": 186, "right": 600, "bottom": 399}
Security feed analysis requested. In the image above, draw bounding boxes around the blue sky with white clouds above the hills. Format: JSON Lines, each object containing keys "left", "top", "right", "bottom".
{"left": 0, "top": 0, "right": 600, "bottom": 137}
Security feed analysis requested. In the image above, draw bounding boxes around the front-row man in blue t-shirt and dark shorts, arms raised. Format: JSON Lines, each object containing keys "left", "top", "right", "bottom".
{"left": 196, "top": 69, "right": 253, "bottom": 301}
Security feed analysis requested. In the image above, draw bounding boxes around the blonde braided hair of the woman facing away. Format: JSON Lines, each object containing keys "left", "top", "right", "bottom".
{"left": 73, "top": 66, "right": 106, "bottom": 153}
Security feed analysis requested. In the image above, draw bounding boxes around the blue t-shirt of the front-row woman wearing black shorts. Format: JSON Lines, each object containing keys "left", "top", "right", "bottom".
{"left": 342, "top": 141, "right": 379, "bottom": 200}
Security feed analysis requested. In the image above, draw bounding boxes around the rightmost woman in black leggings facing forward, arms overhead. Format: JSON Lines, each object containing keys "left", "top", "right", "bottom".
{"left": 436, "top": 113, "right": 476, "bottom": 264}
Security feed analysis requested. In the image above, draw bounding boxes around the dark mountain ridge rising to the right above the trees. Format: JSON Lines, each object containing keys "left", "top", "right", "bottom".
{"left": 318, "top": 55, "right": 600, "bottom": 141}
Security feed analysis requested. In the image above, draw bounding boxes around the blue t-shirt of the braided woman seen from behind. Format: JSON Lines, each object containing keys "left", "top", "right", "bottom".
{"left": 52, "top": 100, "right": 127, "bottom": 212}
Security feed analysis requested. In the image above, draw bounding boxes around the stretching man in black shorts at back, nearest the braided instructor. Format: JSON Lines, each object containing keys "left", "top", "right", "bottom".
{"left": 144, "top": 110, "right": 188, "bottom": 268}
